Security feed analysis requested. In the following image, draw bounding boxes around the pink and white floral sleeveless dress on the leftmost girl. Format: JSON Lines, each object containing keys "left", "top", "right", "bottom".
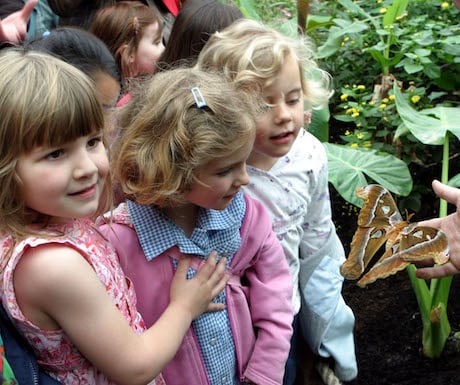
{"left": 0, "top": 220, "right": 164, "bottom": 385}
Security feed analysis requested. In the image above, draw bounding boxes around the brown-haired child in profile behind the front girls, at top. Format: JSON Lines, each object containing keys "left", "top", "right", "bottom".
{"left": 90, "top": 1, "right": 165, "bottom": 100}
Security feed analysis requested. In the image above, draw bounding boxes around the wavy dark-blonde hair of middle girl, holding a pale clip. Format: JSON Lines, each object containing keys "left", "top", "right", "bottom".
{"left": 114, "top": 68, "right": 255, "bottom": 207}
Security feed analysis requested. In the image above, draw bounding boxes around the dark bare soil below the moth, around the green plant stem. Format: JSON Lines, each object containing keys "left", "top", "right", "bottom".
{"left": 344, "top": 271, "right": 460, "bottom": 385}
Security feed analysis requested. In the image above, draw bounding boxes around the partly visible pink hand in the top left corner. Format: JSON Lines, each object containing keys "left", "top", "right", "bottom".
{"left": 0, "top": 0, "right": 38, "bottom": 43}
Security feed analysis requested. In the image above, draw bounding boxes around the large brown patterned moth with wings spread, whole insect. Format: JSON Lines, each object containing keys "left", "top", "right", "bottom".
{"left": 340, "top": 184, "right": 449, "bottom": 287}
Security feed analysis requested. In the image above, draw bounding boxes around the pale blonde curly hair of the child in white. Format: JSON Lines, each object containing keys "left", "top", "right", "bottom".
{"left": 197, "top": 19, "right": 332, "bottom": 107}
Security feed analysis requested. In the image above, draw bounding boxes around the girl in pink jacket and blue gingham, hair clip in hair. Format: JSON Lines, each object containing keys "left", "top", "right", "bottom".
{"left": 101, "top": 68, "right": 293, "bottom": 385}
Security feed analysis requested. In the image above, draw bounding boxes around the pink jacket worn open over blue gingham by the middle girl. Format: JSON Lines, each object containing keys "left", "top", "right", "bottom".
{"left": 101, "top": 196, "right": 293, "bottom": 385}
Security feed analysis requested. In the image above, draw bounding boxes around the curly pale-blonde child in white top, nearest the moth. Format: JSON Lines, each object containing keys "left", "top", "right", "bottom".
{"left": 198, "top": 20, "right": 357, "bottom": 384}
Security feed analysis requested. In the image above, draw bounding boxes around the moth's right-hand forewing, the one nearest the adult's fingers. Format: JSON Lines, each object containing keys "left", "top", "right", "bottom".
{"left": 398, "top": 223, "right": 449, "bottom": 265}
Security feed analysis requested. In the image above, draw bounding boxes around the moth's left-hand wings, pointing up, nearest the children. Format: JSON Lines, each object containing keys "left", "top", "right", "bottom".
{"left": 340, "top": 184, "right": 403, "bottom": 279}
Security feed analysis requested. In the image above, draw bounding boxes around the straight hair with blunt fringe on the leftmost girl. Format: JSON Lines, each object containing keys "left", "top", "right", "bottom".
{"left": 0, "top": 48, "right": 111, "bottom": 236}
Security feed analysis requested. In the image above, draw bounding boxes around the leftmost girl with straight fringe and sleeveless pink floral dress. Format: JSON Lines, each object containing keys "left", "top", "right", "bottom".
{"left": 0, "top": 48, "right": 226, "bottom": 385}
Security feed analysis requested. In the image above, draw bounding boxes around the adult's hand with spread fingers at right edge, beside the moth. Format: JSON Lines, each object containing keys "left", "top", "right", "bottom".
{"left": 416, "top": 180, "right": 460, "bottom": 279}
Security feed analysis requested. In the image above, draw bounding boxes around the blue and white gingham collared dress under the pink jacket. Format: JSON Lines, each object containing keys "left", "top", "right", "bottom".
{"left": 128, "top": 192, "right": 246, "bottom": 385}
